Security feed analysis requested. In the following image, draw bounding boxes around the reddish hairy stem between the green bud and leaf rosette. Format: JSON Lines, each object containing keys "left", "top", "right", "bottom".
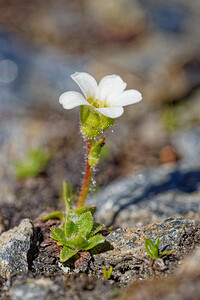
{"left": 76, "top": 140, "right": 92, "bottom": 208}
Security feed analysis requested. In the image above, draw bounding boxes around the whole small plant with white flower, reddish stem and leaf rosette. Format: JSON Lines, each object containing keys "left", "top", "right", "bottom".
{"left": 49, "top": 72, "right": 142, "bottom": 262}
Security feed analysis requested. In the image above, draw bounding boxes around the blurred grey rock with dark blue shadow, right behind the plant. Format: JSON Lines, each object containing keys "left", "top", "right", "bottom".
{"left": 88, "top": 127, "right": 200, "bottom": 227}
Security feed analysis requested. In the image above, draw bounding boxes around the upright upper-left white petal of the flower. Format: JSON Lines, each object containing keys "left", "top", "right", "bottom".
{"left": 71, "top": 72, "right": 97, "bottom": 99}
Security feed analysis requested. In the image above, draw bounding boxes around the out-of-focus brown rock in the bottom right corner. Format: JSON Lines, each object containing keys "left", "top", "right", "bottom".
{"left": 121, "top": 248, "right": 200, "bottom": 300}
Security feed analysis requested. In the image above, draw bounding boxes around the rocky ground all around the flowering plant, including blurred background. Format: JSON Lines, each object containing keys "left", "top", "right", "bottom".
{"left": 0, "top": 0, "right": 200, "bottom": 300}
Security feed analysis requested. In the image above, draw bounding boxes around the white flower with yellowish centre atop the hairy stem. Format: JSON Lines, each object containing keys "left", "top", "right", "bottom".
{"left": 59, "top": 72, "right": 142, "bottom": 119}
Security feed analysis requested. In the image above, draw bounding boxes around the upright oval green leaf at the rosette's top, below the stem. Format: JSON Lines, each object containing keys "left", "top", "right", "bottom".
{"left": 77, "top": 211, "right": 93, "bottom": 237}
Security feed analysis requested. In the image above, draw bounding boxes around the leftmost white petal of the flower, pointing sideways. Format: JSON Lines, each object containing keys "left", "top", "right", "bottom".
{"left": 59, "top": 92, "right": 91, "bottom": 109}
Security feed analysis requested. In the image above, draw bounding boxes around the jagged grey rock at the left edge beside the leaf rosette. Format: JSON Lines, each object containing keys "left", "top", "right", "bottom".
{"left": 0, "top": 219, "right": 35, "bottom": 279}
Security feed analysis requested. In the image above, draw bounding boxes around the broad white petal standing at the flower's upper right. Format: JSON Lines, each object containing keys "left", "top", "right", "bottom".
{"left": 96, "top": 75, "right": 126, "bottom": 104}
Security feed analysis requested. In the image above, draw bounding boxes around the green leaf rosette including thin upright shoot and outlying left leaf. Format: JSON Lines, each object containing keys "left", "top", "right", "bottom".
{"left": 42, "top": 181, "right": 105, "bottom": 262}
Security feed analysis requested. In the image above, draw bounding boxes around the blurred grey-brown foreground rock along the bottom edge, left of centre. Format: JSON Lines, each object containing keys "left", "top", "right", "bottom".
{"left": 6, "top": 274, "right": 121, "bottom": 300}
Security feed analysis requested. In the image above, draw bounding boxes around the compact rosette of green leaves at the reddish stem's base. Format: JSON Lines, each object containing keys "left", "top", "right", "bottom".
{"left": 51, "top": 206, "right": 105, "bottom": 262}
